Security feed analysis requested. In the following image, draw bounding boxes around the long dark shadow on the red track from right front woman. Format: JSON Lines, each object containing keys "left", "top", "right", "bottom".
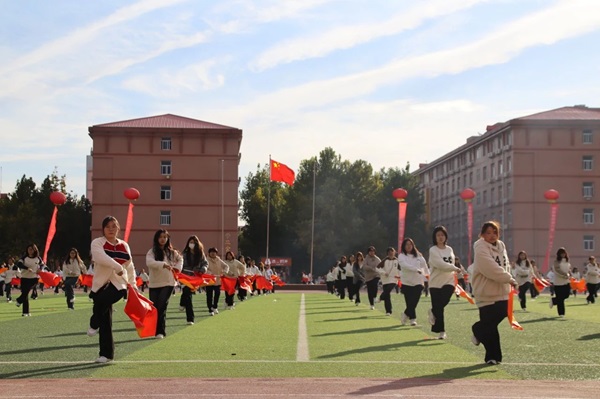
{"left": 348, "top": 364, "right": 494, "bottom": 396}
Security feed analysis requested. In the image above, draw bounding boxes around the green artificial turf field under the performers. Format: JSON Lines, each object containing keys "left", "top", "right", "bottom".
{"left": 0, "top": 291, "right": 600, "bottom": 380}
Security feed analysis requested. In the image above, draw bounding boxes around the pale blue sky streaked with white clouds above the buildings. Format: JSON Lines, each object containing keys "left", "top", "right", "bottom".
{"left": 0, "top": 0, "right": 600, "bottom": 195}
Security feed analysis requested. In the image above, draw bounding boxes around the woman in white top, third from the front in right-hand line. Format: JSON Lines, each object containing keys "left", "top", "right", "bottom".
{"left": 398, "top": 238, "right": 429, "bottom": 326}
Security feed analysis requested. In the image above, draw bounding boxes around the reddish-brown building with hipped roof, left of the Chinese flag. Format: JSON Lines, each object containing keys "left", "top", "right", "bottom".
{"left": 87, "top": 114, "right": 242, "bottom": 269}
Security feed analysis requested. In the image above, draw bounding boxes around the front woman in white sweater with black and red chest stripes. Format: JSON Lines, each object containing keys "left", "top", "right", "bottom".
{"left": 87, "top": 216, "right": 135, "bottom": 363}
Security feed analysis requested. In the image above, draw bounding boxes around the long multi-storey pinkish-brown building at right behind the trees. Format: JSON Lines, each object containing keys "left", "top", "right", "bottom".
{"left": 415, "top": 105, "right": 600, "bottom": 268}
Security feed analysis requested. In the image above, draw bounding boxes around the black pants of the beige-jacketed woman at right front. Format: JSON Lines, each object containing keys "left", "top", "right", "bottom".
{"left": 471, "top": 302, "right": 512, "bottom": 362}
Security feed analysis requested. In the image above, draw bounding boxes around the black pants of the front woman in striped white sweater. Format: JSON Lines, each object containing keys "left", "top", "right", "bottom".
{"left": 90, "top": 283, "right": 127, "bottom": 359}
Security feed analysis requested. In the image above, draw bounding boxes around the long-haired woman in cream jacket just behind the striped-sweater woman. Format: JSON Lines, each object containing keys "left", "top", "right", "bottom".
{"left": 146, "top": 229, "right": 183, "bottom": 339}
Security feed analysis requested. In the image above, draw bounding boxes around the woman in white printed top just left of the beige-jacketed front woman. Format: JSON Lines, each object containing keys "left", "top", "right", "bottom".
{"left": 428, "top": 226, "right": 462, "bottom": 339}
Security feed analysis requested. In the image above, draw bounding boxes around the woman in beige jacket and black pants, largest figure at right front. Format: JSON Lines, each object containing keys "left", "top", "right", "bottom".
{"left": 471, "top": 221, "right": 517, "bottom": 365}
